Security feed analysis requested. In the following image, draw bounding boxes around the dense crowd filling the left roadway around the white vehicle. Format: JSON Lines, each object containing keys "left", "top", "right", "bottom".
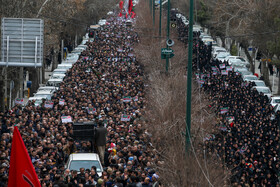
{"left": 0, "top": 17, "right": 160, "bottom": 187}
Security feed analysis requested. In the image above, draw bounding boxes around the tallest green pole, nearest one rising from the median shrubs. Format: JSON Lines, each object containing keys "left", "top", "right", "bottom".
{"left": 186, "top": 0, "right": 193, "bottom": 152}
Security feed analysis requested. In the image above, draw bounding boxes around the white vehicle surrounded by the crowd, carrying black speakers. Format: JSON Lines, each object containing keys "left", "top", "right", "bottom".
{"left": 65, "top": 153, "right": 103, "bottom": 177}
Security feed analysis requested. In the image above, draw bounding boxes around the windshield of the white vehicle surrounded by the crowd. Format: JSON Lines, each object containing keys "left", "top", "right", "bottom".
{"left": 69, "top": 160, "right": 102, "bottom": 172}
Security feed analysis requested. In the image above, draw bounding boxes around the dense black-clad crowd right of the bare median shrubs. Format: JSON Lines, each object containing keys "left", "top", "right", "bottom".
{"left": 177, "top": 11, "right": 280, "bottom": 187}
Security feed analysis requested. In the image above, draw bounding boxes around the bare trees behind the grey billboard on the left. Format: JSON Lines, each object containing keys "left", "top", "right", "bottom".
{"left": 0, "top": 0, "right": 116, "bottom": 111}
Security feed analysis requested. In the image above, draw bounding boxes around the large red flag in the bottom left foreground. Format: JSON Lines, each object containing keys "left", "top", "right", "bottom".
{"left": 8, "top": 127, "right": 41, "bottom": 187}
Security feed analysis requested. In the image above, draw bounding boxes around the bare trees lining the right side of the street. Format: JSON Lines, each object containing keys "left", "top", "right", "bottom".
{"left": 173, "top": 0, "right": 280, "bottom": 94}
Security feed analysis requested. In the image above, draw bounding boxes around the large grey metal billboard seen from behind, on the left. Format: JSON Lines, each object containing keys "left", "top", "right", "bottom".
{"left": 0, "top": 18, "right": 44, "bottom": 68}
